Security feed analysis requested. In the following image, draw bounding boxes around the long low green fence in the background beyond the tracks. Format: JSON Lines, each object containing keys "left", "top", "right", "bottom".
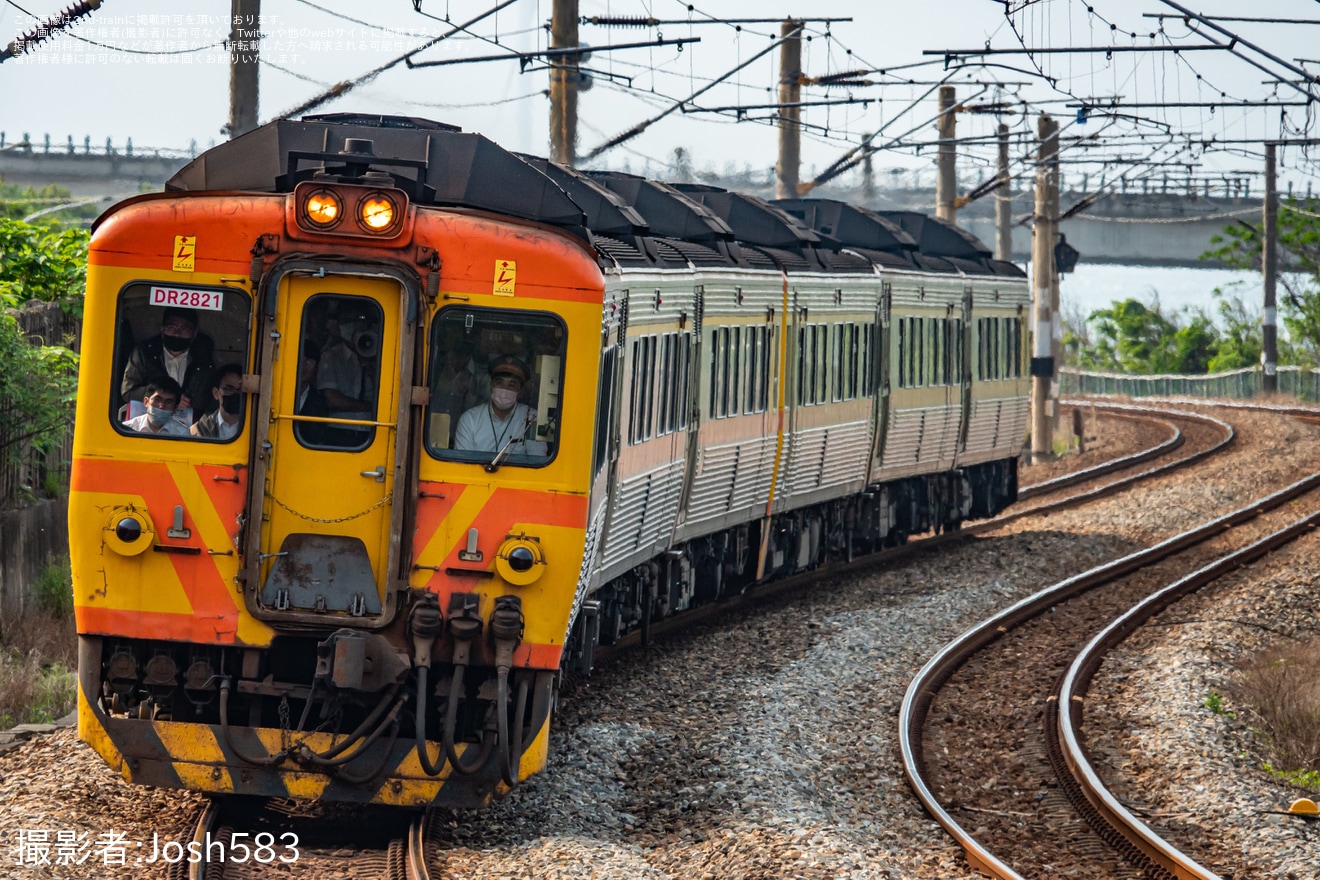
{"left": 1059, "top": 367, "right": 1320, "bottom": 402}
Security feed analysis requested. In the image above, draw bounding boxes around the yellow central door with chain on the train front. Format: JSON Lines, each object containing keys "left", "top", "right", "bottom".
{"left": 247, "top": 276, "right": 413, "bottom": 624}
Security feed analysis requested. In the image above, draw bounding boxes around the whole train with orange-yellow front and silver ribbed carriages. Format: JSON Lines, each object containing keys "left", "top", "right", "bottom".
{"left": 69, "top": 113, "right": 1030, "bottom": 807}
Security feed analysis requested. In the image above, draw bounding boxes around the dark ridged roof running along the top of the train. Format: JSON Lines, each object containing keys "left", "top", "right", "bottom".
{"left": 165, "top": 113, "right": 1022, "bottom": 276}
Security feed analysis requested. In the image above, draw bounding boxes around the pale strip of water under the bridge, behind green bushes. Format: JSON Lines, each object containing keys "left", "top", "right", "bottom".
{"left": 1027, "top": 263, "right": 1282, "bottom": 329}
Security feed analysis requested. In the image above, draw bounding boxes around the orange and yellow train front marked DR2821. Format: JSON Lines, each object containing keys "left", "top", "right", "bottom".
{"left": 70, "top": 170, "right": 603, "bottom": 806}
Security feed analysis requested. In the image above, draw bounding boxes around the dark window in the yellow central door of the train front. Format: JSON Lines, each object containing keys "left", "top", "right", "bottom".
{"left": 293, "top": 293, "right": 384, "bottom": 451}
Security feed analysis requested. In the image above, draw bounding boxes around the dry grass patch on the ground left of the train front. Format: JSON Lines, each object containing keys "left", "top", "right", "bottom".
{"left": 0, "top": 558, "right": 78, "bottom": 730}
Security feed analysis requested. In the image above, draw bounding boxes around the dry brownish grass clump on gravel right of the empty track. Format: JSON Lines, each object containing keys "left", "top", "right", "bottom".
{"left": 1236, "top": 640, "right": 1320, "bottom": 790}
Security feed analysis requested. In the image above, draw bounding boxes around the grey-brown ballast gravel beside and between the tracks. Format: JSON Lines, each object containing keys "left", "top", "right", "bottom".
{"left": 0, "top": 406, "right": 1320, "bottom": 880}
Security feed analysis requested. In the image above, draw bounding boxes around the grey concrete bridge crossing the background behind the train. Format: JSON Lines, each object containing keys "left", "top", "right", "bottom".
{"left": 0, "top": 136, "right": 1261, "bottom": 267}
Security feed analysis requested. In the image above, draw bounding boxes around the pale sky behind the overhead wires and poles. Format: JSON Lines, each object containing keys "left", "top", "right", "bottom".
{"left": 0, "top": 0, "right": 1320, "bottom": 187}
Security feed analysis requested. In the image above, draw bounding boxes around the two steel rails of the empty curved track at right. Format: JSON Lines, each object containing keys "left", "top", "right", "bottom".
{"left": 900, "top": 401, "right": 1320, "bottom": 880}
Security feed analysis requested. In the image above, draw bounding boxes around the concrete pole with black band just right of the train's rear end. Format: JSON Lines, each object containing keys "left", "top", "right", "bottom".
{"left": 1031, "top": 115, "right": 1059, "bottom": 463}
